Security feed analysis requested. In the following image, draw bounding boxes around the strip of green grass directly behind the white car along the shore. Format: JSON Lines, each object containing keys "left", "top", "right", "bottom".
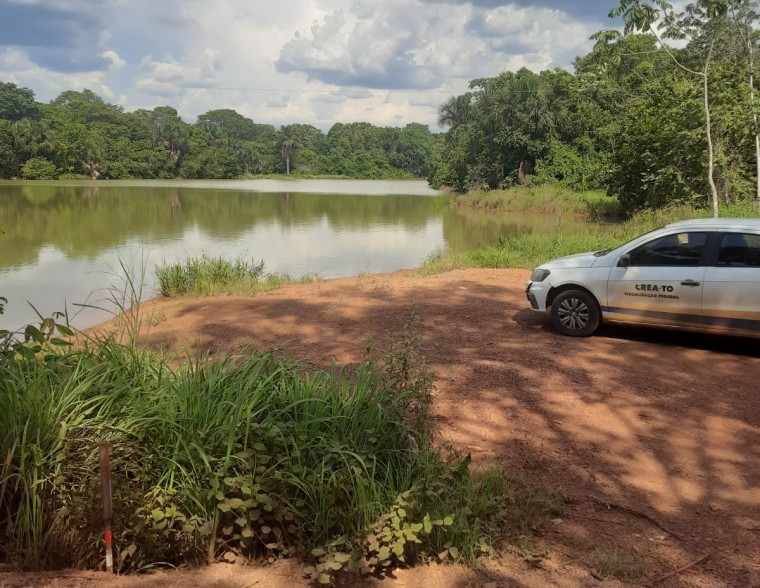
{"left": 415, "top": 203, "right": 757, "bottom": 275}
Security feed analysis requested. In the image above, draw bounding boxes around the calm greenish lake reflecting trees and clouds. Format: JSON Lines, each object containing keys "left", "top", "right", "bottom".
{"left": 0, "top": 180, "right": 592, "bottom": 330}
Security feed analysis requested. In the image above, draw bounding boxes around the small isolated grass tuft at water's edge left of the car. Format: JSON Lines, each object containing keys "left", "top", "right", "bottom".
{"left": 156, "top": 254, "right": 320, "bottom": 297}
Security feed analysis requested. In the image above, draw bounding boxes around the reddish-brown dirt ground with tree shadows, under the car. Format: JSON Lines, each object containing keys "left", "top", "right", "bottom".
{"left": 0, "top": 269, "right": 760, "bottom": 588}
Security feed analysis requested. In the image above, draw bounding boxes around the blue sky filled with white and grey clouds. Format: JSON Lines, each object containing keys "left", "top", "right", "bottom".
{"left": 0, "top": 0, "right": 617, "bottom": 130}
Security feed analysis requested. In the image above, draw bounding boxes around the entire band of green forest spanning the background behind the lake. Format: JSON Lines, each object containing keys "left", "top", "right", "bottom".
{"left": 0, "top": 0, "right": 760, "bottom": 212}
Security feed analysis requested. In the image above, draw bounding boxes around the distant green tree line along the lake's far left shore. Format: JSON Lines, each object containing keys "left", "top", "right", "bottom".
{"left": 0, "top": 82, "right": 440, "bottom": 179}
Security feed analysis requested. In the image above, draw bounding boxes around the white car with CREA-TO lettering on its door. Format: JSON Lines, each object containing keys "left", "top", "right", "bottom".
{"left": 526, "top": 219, "right": 760, "bottom": 337}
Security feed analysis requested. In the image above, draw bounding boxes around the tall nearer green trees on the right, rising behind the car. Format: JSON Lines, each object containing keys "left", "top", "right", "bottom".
{"left": 430, "top": 0, "right": 760, "bottom": 211}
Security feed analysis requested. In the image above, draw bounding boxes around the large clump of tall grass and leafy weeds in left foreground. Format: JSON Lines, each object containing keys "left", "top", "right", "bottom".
{"left": 0, "top": 312, "right": 556, "bottom": 581}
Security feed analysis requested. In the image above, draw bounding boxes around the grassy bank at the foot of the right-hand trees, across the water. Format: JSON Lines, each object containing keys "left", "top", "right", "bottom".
{"left": 453, "top": 184, "right": 622, "bottom": 218}
